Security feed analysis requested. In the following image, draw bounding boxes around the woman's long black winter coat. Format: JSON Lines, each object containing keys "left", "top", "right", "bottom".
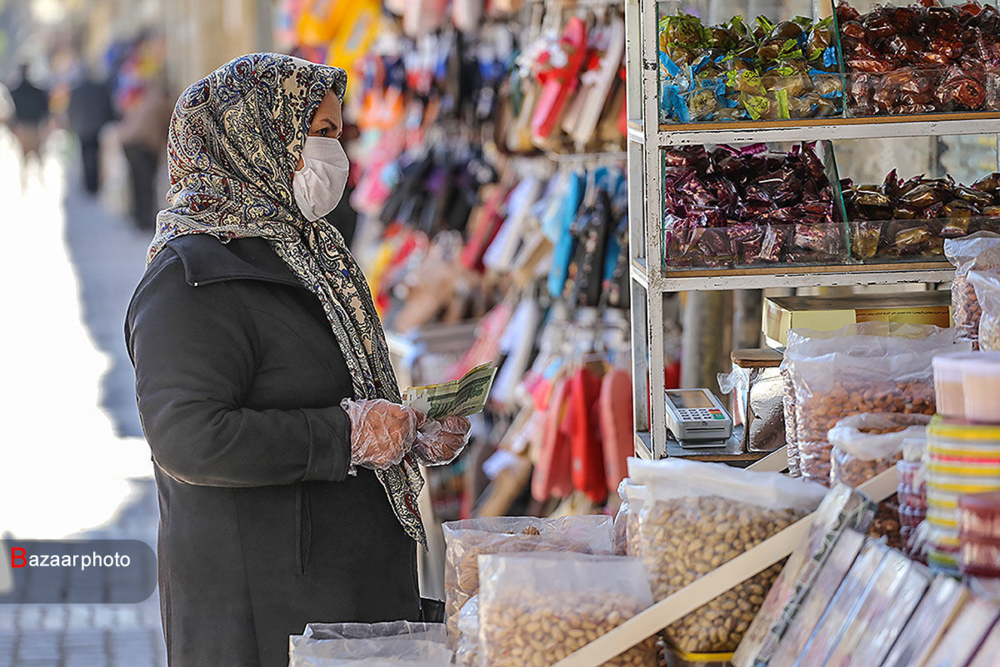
{"left": 125, "top": 235, "right": 420, "bottom": 667}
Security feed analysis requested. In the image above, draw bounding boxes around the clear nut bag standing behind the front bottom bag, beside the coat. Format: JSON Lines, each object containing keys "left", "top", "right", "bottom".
{"left": 442, "top": 515, "right": 613, "bottom": 646}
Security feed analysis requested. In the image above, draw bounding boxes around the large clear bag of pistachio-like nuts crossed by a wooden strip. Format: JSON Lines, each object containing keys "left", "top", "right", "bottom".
{"left": 629, "top": 459, "right": 826, "bottom": 653}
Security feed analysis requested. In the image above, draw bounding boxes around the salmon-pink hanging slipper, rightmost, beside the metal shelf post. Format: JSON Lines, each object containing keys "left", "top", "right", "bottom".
{"left": 598, "top": 368, "right": 635, "bottom": 489}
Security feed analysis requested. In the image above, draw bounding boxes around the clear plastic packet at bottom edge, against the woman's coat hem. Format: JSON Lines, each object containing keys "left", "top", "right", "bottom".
{"left": 288, "top": 621, "right": 451, "bottom": 667}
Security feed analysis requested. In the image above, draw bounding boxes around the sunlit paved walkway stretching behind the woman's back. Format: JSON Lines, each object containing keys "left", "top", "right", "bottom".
{"left": 0, "top": 132, "right": 166, "bottom": 667}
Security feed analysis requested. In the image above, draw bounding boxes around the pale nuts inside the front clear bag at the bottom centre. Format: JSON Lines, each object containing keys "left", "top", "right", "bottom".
{"left": 479, "top": 590, "right": 657, "bottom": 667}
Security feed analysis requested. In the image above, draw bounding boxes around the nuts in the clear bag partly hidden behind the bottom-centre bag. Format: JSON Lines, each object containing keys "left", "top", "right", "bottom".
{"left": 444, "top": 526, "right": 593, "bottom": 641}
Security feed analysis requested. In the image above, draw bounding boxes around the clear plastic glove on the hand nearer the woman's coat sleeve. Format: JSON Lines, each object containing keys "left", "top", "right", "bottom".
{"left": 340, "top": 398, "right": 424, "bottom": 470}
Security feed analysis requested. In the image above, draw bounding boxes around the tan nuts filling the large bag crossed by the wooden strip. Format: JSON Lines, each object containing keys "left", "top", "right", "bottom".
{"left": 641, "top": 496, "right": 807, "bottom": 653}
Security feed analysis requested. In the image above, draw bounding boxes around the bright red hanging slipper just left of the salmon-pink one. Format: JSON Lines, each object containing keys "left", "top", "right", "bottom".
{"left": 567, "top": 367, "right": 608, "bottom": 503}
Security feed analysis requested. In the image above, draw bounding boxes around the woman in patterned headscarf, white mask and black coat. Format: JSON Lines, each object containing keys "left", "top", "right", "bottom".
{"left": 125, "top": 54, "right": 469, "bottom": 667}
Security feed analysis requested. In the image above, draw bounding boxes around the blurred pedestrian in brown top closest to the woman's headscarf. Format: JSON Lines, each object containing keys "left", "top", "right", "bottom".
{"left": 118, "top": 81, "right": 174, "bottom": 231}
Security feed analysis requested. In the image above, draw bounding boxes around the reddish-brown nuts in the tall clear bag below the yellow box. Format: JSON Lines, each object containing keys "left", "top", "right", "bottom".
{"left": 796, "top": 381, "right": 936, "bottom": 486}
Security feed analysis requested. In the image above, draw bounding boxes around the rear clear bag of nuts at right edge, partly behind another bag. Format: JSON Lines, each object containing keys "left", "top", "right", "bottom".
{"left": 944, "top": 232, "right": 1000, "bottom": 350}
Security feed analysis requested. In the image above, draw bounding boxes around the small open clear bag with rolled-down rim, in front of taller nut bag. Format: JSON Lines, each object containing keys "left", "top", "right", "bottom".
{"left": 827, "top": 412, "right": 931, "bottom": 488}
